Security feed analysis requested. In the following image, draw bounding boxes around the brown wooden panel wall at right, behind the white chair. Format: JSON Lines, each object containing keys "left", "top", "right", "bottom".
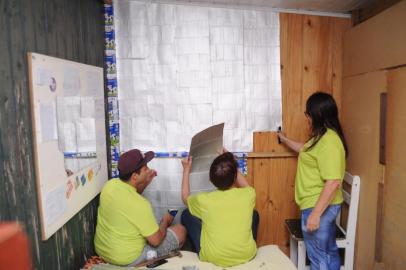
{"left": 343, "top": 1, "right": 406, "bottom": 269}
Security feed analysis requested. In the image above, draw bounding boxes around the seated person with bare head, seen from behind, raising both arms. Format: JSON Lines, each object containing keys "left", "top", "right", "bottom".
{"left": 181, "top": 152, "right": 259, "bottom": 267}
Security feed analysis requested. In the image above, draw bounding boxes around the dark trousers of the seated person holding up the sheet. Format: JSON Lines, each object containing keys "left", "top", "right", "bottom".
{"left": 180, "top": 208, "right": 259, "bottom": 254}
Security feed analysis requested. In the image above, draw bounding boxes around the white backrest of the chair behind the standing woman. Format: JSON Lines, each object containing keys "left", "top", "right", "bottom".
{"left": 337, "top": 172, "right": 361, "bottom": 241}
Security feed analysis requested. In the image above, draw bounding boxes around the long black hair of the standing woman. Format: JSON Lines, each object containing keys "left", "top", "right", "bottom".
{"left": 305, "top": 92, "right": 348, "bottom": 156}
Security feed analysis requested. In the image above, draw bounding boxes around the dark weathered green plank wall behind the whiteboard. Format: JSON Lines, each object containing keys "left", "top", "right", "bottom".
{"left": 0, "top": 0, "right": 104, "bottom": 269}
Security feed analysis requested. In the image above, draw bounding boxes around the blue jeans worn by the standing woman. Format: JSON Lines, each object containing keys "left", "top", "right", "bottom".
{"left": 302, "top": 204, "right": 341, "bottom": 270}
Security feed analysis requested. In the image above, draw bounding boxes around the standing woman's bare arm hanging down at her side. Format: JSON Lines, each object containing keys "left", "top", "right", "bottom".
{"left": 306, "top": 180, "right": 341, "bottom": 231}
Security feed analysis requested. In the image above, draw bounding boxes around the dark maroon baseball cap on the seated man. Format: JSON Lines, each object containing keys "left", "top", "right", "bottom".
{"left": 118, "top": 149, "right": 155, "bottom": 175}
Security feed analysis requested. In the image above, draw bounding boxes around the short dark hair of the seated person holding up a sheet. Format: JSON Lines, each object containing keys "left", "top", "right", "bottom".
{"left": 210, "top": 152, "right": 238, "bottom": 190}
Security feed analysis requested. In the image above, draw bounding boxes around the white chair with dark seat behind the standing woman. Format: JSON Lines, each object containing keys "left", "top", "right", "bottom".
{"left": 285, "top": 172, "right": 361, "bottom": 270}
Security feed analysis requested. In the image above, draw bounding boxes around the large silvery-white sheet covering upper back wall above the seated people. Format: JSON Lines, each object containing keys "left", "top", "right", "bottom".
{"left": 114, "top": 0, "right": 282, "bottom": 152}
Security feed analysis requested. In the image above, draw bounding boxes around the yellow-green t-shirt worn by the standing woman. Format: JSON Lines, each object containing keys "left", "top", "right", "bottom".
{"left": 295, "top": 129, "right": 345, "bottom": 210}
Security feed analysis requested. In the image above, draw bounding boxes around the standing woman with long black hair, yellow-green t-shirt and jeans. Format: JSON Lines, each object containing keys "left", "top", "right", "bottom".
{"left": 278, "top": 92, "right": 348, "bottom": 270}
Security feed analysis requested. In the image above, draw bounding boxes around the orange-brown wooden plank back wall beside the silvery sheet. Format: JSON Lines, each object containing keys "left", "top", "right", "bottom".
{"left": 248, "top": 14, "right": 351, "bottom": 251}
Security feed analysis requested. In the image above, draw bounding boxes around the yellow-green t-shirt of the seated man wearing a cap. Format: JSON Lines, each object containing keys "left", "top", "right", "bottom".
{"left": 94, "top": 179, "right": 159, "bottom": 265}
